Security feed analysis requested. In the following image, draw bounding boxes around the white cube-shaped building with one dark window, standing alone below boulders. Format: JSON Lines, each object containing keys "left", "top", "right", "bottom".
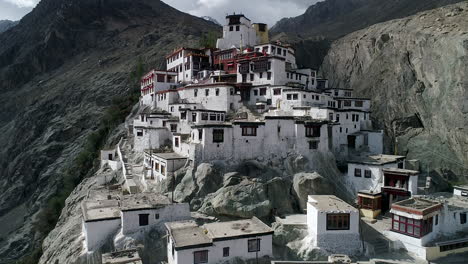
{"left": 307, "top": 195, "right": 362, "bottom": 255}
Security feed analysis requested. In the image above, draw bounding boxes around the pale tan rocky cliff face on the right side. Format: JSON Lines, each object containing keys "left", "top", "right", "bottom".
{"left": 322, "top": 2, "right": 468, "bottom": 182}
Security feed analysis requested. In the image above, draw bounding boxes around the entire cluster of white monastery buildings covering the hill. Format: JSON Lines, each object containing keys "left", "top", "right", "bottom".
{"left": 89, "top": 12, "right": 468, "bottom": 264}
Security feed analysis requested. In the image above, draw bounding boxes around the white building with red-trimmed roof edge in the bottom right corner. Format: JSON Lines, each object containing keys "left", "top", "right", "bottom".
{"left": 384, "top": 193, "right": 468, "bottom": 261}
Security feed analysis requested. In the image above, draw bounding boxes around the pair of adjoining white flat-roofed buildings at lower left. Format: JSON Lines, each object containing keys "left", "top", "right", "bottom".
{"left": 81, "top": 193, "right": 190, "bottom": 252}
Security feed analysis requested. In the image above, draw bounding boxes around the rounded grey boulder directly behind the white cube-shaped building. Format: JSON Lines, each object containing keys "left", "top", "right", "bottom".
{"left": 293, "top": 172, "right": 335, "bottom": 210}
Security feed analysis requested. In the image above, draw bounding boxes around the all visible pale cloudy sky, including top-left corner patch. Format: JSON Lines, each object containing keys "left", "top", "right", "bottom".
{"left": 0, "top": 0, "right": 319, "bottom": 27}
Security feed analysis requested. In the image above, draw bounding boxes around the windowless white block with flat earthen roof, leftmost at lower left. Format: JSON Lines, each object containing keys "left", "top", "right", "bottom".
{"left": 81, "top": 200, "right": 120, "bottom": 252}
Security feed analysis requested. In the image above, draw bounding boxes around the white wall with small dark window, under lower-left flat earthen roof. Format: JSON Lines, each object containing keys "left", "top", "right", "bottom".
{"left": 121, "top": 203, "right": 190, "bottom": 235}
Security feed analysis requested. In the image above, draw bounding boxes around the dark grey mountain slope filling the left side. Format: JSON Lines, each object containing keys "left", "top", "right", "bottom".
{"left": 0, "top": 0, "right": 219, "bottom": 263}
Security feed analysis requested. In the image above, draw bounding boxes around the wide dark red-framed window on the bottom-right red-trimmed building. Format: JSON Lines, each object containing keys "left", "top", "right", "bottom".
{"left": 392, "top": 214, "right": 432, "bottom": 237}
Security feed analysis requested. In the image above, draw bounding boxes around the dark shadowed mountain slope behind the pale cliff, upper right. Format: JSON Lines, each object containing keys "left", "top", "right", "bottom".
{"left": 271, "top": 0, "right": 463, "bottom": 68}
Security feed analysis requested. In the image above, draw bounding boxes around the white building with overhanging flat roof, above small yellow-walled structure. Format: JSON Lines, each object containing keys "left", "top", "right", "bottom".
{"left": 346, "top": 154, "right": 405, "bottom": 195}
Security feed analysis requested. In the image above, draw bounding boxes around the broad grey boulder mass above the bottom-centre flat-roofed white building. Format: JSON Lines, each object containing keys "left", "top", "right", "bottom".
{"left": 200, "top": 178, "right": 294, "bottom": 218}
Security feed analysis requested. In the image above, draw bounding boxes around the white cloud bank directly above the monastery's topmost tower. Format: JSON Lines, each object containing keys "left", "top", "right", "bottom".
{"left": 163, "top": 0, "right": 320, "bottom": 27}
